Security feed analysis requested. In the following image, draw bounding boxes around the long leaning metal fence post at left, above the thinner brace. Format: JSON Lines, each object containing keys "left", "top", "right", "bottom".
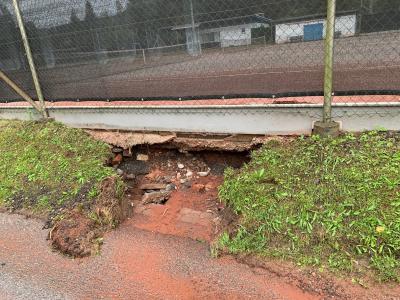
{"left": 13, "top": 0, "right": 49, "bottom": 118}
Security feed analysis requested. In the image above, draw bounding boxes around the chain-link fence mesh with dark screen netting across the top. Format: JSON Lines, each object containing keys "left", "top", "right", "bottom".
{"left": 0, "top": 0, "right": 400, "bottom": 108}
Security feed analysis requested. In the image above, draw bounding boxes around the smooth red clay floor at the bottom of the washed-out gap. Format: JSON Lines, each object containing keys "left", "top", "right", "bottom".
{"left": 130, "top": 176, "right": 222, "bottom": 241}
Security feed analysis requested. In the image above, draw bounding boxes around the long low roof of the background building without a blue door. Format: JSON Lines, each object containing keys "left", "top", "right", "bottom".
{"left": 172, "top": 13, "right": 272, "bottom": 30}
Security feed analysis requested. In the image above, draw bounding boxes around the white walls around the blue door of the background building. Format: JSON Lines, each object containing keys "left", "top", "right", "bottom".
{"left": 275, "top": 15, "right": 357, "bottom": 44}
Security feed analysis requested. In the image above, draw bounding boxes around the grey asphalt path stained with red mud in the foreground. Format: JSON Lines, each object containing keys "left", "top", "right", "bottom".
{"left": 0, "top": 214, "right": 317, "bottom": 299}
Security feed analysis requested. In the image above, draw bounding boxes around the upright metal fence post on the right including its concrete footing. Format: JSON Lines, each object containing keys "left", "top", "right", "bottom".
{"left": 313, "top": 0, "right": 339, "bottom": 136}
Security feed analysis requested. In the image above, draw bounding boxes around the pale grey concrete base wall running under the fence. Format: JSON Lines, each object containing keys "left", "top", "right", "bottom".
{"left": 0, "top": 103, "right": 400, "bottom": 135}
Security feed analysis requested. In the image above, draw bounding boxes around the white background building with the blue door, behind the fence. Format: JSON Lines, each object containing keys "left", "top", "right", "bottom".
{"left": 274, "top": 12, "right": 357, "bottom": 44}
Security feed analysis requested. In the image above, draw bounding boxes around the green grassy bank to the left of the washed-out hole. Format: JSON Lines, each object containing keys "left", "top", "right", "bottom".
{"left": 0, "top": 121, "right": 114, "bottom": 214}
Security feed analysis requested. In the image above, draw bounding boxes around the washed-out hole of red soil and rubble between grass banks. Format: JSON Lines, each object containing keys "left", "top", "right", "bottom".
{"left": 119, "top": 147, "right": 248, "bottom": 242}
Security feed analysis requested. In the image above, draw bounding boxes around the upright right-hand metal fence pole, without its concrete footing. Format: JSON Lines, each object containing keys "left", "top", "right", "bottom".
{"left": 323, "top": 0, "right": 336, "bottom": 123}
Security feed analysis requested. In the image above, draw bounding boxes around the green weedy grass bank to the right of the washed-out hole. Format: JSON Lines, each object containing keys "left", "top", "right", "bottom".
{"left": 217, "top": 132, "right": 400, "bottom": 281}
